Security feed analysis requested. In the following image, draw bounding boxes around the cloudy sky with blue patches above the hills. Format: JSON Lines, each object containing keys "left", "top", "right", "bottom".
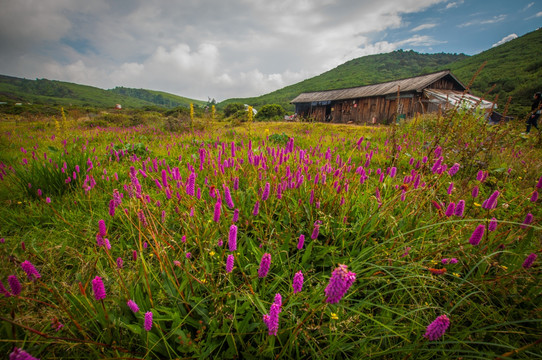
{"left": 0, "top": 0, "right": 542, "bottom": 101}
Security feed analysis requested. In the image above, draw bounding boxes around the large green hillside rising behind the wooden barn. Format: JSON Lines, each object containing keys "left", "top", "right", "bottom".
{"left": 220, "top": 30, "right": 542, "bottom": 115}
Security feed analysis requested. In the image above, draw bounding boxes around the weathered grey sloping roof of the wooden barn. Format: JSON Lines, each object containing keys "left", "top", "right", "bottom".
{"left": 291, "top": 70, "right": 465, "bottom": 104}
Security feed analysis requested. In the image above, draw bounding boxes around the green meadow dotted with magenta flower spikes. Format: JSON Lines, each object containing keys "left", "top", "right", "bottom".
{"left": 0, "top": 111, "right": 542, "bottom": 359}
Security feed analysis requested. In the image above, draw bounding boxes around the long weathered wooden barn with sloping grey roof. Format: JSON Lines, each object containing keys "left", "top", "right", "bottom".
{"left": 291, "top": 70, "right": 474, "bottom": 124}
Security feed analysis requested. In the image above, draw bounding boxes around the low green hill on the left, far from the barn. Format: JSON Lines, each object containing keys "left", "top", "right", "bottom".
{"left": 0, "top": 75, "right": 206, "bottom": 108}
